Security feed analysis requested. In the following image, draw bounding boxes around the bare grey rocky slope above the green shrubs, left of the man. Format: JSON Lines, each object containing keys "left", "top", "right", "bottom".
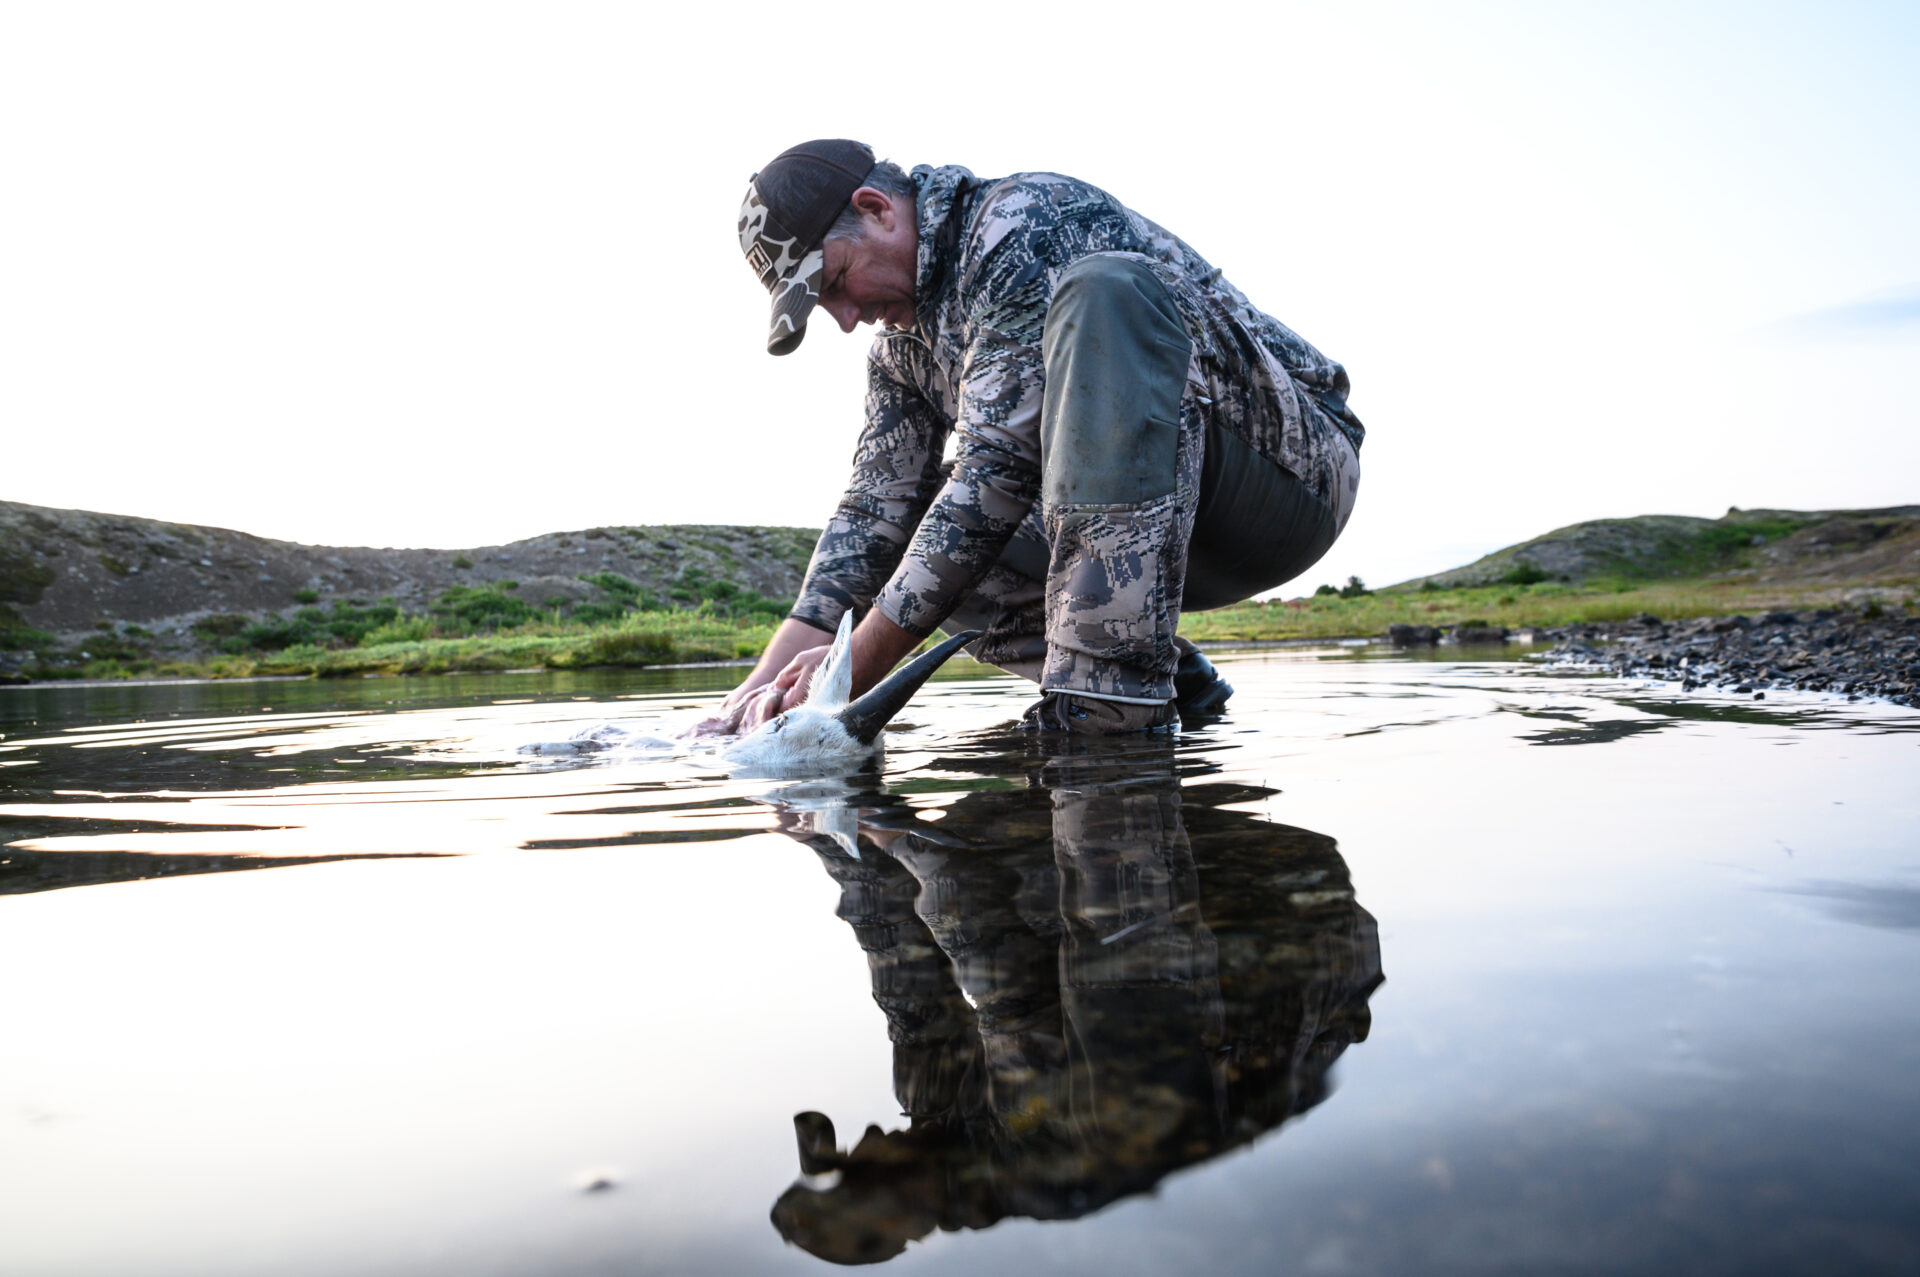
{"left": 0, "top": 501, "right": 818, "bottom": 641}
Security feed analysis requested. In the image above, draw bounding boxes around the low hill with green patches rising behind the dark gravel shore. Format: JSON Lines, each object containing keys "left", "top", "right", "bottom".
{"left": 1390, "top": 505, "right": 1920, "bottom": 590}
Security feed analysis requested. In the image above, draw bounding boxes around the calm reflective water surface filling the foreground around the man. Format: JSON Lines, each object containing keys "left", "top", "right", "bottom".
{"left": 0, "top": 651, "right": 1920, "bottom": 1277}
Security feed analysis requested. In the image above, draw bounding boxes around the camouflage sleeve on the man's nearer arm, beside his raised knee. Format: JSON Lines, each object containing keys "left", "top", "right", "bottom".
{"left": 876, "top": 253, "right": 1052, "bottom": 636}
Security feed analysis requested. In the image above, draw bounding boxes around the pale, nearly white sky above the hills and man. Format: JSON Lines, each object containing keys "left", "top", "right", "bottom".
{"left": 0, "top": 0, "right": 1920, "bottom": 593}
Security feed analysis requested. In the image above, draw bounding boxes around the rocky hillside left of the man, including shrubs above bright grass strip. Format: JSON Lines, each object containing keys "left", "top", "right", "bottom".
{"left": 0, "top": 501, "right": 816, "bottom": 676}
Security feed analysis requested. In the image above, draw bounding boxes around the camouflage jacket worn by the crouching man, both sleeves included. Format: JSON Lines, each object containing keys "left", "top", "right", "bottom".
{"left": 791, "top": 165, "right": 1365, "bottom": 636}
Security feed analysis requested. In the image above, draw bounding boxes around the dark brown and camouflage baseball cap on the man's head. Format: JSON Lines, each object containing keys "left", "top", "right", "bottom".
{"left": 739, "top": 138, "right": 874, "bottom": 355}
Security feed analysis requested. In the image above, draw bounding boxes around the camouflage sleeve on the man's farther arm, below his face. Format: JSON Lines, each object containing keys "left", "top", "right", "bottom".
{"left": 789, "top": 330, "right": 950, "bottom": 630}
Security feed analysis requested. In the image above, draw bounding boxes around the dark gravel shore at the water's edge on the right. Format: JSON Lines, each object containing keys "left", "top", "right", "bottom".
{"left": 1542, "top": 611, "right": 1920, "bottom": 705}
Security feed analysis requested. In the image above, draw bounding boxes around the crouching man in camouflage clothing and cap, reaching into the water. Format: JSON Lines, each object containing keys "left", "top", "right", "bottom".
{"left": 726, "top": 140, "right": 1365, "bottom": 734}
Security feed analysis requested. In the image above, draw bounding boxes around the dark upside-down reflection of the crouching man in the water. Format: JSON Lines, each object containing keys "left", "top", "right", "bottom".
{"left": 774, "top": 753, "right": 1380, "bottom": 1264}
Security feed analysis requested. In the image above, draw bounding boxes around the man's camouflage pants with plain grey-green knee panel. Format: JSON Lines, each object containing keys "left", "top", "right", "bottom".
{"left": 943, "top": 253, "right": 1352, "bottom": 705}
